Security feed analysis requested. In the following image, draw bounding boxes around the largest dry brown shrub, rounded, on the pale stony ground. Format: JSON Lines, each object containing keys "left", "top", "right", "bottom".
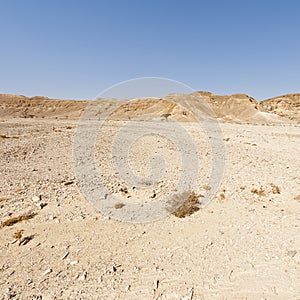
{"left": 166, "top": 192, "right": 201, "bottom": 218}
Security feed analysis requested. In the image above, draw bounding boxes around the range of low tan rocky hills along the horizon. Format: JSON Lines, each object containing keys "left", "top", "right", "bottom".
{"left": 0, "top": 91, "right": 300, "bottom": 124}
